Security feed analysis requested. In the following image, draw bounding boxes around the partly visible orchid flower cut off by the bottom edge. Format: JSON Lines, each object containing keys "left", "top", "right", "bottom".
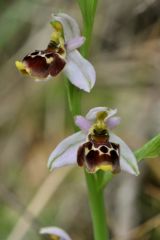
{"left": 40, "top": 227, "right": 71, "bottom": 240}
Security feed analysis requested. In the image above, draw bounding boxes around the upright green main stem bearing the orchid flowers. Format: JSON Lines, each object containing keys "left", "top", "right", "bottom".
{"left": 63, "top": 0, "right": 109, "bottom": 240}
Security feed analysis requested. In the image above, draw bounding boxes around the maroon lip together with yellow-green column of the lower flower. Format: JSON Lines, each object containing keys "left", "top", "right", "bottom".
{"left": 77, "top": 112, "right": 120, "bottom": 173}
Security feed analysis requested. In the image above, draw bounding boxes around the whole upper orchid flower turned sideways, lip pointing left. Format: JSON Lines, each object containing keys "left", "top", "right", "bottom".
{"left": 16, "top": 13, "right": 96, "bottom": 92}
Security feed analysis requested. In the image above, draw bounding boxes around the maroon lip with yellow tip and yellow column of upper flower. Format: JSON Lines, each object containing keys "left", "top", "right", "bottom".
{"left": 16, "top": 23, "right": 66, "bottom": 80}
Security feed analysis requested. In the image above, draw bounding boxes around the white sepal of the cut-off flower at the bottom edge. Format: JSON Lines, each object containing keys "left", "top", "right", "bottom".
{"left": 40, "top": 227, "right": 71, "bottom": 240}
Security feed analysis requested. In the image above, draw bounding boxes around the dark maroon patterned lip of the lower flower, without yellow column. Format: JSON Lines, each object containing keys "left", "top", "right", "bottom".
{"left": 77, "top": 139, "right": 120, "bottom": 173}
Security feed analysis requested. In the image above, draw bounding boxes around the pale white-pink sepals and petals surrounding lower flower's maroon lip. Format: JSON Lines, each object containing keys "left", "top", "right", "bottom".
{"left": 48, "top": 107, "right": 139, "bottom": 176}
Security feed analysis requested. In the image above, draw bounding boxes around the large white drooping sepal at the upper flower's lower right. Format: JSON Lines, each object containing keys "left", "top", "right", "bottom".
{"left": 63, "top": 50, "right": 96, "bottom": 92}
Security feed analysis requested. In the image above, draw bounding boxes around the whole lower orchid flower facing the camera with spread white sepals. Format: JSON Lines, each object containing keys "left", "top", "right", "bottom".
{"left": 48, "top": 107, "right": 139, "bottom": 175}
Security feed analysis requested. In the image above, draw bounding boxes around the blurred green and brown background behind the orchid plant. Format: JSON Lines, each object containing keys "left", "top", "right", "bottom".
{"left": 0, "top": 0, "right": 160, "bottom": 240}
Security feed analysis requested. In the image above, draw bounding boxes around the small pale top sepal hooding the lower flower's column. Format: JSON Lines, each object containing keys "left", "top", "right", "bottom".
{"left": 86, "top": 107, "right": 117, "bottom": 121}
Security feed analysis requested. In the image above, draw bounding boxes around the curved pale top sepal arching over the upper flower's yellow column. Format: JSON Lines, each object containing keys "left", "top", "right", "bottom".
{"left": 51, "top": 13, "right": 80, "bottom": 42}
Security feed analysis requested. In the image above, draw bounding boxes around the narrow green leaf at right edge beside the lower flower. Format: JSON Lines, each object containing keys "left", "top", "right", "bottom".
{"left": 135, "top": 134, "right": 160, "bottom": 161}
